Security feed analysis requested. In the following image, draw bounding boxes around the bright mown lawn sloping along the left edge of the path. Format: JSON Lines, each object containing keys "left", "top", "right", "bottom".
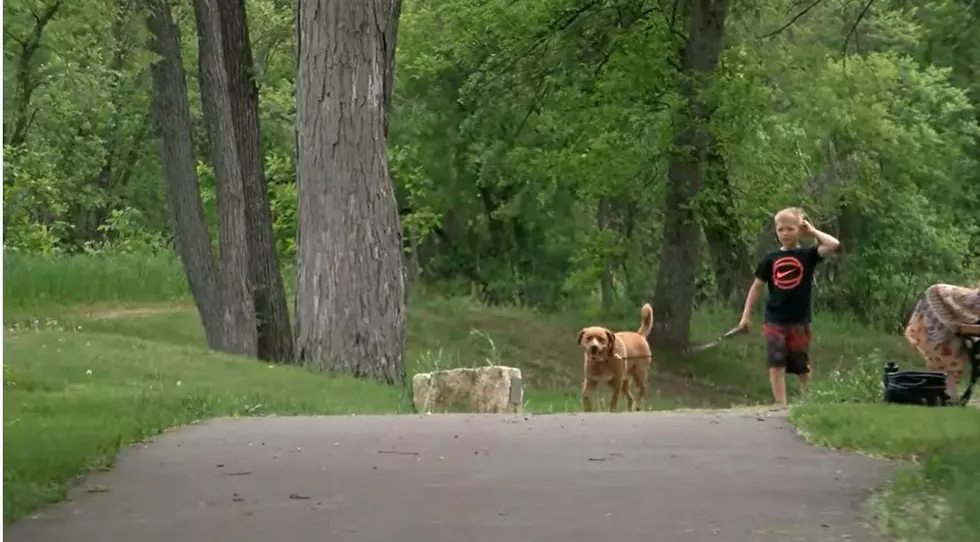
{"left": 3, "top": 330, "right": 411, "bottom": 523}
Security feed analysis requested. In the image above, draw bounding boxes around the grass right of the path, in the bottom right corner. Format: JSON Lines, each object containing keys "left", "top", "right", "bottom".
{"left": 790, "top": 356, "right": 980, "bottom": 542}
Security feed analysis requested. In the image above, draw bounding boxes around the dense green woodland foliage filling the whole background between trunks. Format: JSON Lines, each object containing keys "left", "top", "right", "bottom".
{"left": 4, "top": 0, "right": 980, "bottom": 329}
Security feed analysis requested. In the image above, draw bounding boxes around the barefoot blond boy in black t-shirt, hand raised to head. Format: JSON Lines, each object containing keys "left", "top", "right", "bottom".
{"left": 738, "top": 207, "right": 840, "bottom": 408}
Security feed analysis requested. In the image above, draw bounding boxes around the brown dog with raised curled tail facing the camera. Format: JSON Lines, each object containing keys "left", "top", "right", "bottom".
{"left": 578, "top": 303, "right": 653, "bottom": 412}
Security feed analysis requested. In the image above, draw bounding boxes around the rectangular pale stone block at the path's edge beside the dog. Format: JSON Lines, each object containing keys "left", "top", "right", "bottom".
{"left": 412, "top": 365, "right": 524, "bottom": 414}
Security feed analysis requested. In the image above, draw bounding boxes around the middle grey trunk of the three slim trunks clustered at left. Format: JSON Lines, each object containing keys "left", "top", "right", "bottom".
{"left": 194, "top": 0, "right": 258, "bottom": 357}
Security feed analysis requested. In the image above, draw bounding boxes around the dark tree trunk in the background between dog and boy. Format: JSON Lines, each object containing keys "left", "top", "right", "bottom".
{"left": 651, "top": 0, "right": 728, "bottom": 350}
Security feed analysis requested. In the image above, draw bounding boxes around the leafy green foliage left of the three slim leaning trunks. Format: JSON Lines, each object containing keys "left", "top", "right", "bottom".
{"left": 3, "top": 0, "right": 163, "bottom": 251}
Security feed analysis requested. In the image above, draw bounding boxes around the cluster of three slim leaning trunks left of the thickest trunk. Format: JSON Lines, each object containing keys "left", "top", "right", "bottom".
{"left": 149, "top": 0, "right": 293, "bottom": 361}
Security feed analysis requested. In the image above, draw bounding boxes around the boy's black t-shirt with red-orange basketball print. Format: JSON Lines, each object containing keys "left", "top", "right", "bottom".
{"left": 755, "top": 246, "right": 823, "bottom": 324}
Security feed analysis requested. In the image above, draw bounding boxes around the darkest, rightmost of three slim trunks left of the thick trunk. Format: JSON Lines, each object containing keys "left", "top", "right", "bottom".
{"left": 220, "top": 0, "right": 293, "bottom": 361}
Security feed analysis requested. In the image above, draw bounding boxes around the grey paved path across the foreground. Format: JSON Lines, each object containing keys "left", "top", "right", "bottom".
{"left": 4, "top": 412, "right": 888, "bottom": 542}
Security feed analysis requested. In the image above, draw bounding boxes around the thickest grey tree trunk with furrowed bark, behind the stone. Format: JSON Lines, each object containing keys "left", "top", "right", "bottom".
{"left": 296, "top": 0, "right": 405, "bottom": 384}
